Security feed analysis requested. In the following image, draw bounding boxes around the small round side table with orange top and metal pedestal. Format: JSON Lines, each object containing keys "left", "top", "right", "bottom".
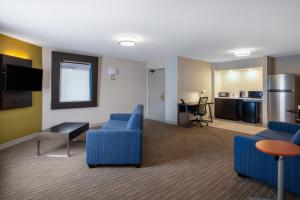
{"left": 255, "top": 140, "right": 300, "bottom": 200}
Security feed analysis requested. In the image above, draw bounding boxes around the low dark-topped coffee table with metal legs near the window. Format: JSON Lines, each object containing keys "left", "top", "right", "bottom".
{"left": 37, "top": 122, "right": 89, "bottom": 157}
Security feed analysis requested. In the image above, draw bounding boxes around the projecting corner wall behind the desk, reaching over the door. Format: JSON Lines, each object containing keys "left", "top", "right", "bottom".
{"left": 148, "top": 56, "right": 212, "bottom": 124}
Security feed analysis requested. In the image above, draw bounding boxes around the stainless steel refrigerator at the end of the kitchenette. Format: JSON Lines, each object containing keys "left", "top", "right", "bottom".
{"left": 268, "top": 74, "right": 300, "bottom": 123}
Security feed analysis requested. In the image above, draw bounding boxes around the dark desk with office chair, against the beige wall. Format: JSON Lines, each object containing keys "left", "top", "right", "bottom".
{"left": 177, "top": 102, "right": 214, "bottom": 126}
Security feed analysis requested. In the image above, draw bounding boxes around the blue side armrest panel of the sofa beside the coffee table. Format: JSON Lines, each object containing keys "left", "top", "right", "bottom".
{"left": 86, "top": 129, "right": 142, "bottom": 164}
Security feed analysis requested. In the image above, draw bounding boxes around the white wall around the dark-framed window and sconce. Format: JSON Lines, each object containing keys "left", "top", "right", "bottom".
{"left": 43, "top": 48, "right": 147, "bottom": 129}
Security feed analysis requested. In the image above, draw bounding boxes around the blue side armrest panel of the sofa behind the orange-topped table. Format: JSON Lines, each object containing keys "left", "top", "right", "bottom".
{"left": 234, "top": 136, "right": 300, "bottom": 194}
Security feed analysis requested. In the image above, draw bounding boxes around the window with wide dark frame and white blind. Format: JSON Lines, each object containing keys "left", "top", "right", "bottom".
{"left": 51, "top": 52, "right": 98, "bottom": 109}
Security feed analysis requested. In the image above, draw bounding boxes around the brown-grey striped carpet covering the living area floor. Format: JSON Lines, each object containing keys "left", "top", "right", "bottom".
{"left": 0, "top": 120, "right": 300, "bottom": 200}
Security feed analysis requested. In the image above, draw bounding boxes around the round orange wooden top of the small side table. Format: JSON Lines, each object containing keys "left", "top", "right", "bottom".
{"left": 255, "top": 140, "right": 300, "bottom": 156}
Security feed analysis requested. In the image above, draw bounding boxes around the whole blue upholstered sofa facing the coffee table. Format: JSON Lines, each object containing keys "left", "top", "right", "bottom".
{"left": 86, "top": 105, "right": 144, "bottom": 167}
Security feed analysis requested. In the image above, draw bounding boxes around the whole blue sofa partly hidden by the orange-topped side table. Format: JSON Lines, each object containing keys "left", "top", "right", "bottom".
{"left": 234, "top": 122, "right": 300, "bottom": 195}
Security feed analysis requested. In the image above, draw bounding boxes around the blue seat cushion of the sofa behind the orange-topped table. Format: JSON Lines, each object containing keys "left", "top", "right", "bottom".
{"left": 255, "top": 129, "right": 294, "bottom": 142}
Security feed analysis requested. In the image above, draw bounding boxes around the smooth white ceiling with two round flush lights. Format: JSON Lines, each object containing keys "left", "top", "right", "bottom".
{"left": 0, "top": 0, "right": 300, "bottom": 62}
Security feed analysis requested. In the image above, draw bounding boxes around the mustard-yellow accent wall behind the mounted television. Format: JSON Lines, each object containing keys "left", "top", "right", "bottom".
{"left": 0, "top": 34, "right": 42, "bottom": 144}
